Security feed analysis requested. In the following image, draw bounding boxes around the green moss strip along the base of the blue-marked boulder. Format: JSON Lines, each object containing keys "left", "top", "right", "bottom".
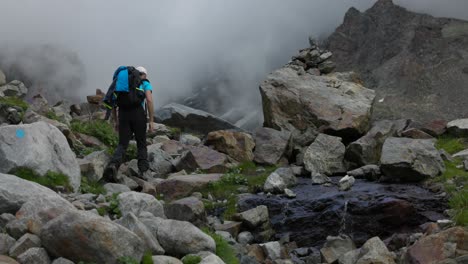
{"left": 9, "top": 167, "right": 73, "bottom": 192}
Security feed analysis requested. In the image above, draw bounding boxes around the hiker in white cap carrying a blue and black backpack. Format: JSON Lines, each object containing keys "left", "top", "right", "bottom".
{"left": 103, "top": 66, "right": 154, "bottom": 182}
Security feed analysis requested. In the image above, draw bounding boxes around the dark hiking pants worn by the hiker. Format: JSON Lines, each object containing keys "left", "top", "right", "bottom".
{"left": 111, "top": 107, "right": 149, "bottom": 173}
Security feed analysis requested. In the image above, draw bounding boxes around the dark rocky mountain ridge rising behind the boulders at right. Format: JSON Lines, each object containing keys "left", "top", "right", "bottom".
{"left": 326, "top": 0, "right": 468, "bottom": 121}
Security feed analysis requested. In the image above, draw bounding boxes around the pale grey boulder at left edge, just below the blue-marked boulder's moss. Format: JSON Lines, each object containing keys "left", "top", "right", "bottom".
{"left": 0, "top": 173, "right": 66, "bottom": 214}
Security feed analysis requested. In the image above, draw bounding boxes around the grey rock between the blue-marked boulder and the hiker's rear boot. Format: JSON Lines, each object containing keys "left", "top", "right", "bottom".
{"left": 79, "top": 150, "right": 110, "bottom": 182}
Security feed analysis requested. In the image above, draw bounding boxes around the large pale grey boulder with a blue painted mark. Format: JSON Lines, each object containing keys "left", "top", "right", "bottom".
{"left": 0, "top": 122, "right": 81, "bottom": 191}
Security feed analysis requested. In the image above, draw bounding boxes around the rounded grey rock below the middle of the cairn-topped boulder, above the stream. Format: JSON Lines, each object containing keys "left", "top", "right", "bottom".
{"left": 304, "top": 134, "right": 346, "bottom": 176}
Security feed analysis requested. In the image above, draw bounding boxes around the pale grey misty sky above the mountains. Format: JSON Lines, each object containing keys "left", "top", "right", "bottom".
{"left": 0, "top": 0, "right": 468, "bottom": 114}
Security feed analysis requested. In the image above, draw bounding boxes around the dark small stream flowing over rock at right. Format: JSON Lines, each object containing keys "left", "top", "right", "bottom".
{"left": 239, "top": 178, "right": 447, "bottom": 246}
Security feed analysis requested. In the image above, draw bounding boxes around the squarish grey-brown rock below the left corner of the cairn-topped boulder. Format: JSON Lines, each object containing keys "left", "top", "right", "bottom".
{"left": 254, "top": 127, "right": 291, "bottom": 165}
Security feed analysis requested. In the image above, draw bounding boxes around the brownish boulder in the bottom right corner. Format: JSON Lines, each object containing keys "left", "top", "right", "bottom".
{"left": 404, "top": 227, "right": 468, "bottom": 263}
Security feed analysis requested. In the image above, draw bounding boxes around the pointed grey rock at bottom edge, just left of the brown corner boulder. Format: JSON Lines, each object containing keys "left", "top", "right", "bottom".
{"left": 356, "top": 237, "right": 395, "bottom": 264}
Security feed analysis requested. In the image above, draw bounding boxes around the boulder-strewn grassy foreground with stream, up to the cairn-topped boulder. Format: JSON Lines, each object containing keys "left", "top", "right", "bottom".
{"left": 0, "top": 5, "right": 468, "bottom": 264}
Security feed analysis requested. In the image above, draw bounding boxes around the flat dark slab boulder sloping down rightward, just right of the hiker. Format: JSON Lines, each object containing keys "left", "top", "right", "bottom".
{"left": 155, "top": 103, "right": 241, "bottom": 134}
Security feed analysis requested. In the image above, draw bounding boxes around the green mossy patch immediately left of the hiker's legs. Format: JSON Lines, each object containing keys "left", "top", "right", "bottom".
{"left": 70, "top": 120, "right": 119, "bottom": 148}
